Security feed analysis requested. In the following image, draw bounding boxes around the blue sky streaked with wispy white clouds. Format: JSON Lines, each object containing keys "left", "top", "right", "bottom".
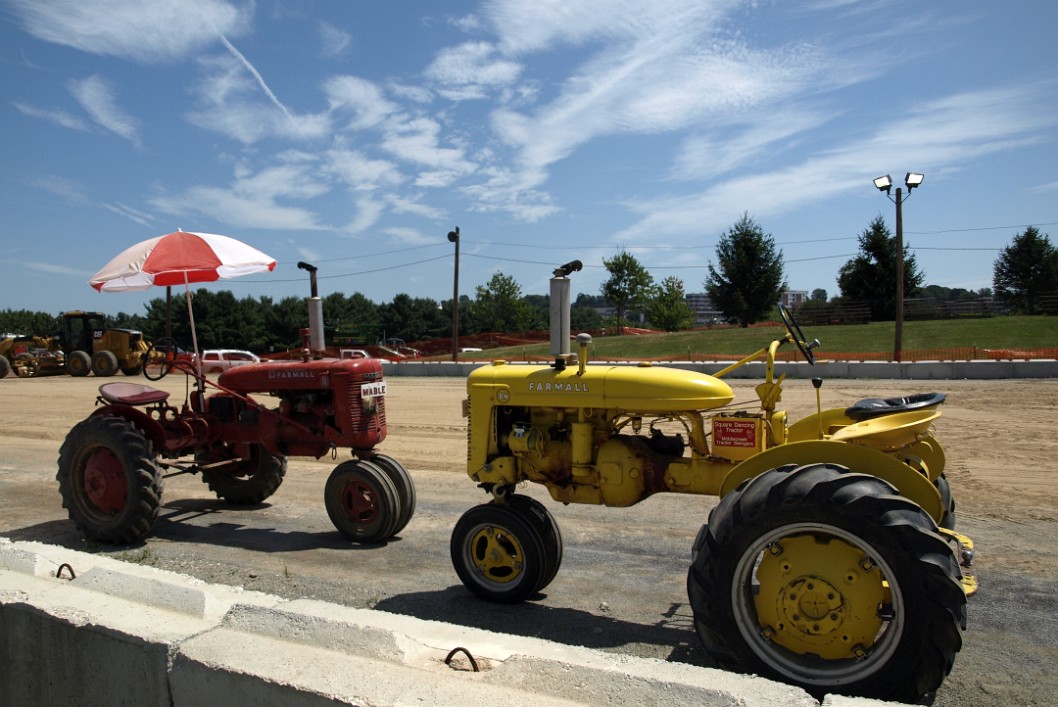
{"left": 0, "top": 0, "right": 1058, "bottom": 313}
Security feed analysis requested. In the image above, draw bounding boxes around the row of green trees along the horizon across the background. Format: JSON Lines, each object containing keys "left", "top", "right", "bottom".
{"left": 0, "top": 214, "right": 1058, "bottom": 351}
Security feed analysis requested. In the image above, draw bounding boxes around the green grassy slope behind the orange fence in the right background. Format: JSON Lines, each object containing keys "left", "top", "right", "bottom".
{"left": 460, "top": 315, "right": 1058, "bottom": 360}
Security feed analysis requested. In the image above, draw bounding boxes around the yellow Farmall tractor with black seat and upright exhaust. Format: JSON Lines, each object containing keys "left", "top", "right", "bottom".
{"left": 451, "top": 261, "right": 977, "bottom": 702}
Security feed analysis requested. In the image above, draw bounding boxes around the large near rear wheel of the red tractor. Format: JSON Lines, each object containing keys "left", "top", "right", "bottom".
{"left": 55, "top": 416, "right": 162, "bottom": 544}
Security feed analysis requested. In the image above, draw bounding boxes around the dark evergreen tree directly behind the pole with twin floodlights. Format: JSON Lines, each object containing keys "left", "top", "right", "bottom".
{"left": 838, "top": 216, "right": 925, "bottom": 322}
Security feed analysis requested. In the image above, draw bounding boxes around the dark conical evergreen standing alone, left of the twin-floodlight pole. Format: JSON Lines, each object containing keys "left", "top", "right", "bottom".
{"left": 705, "top": 214, "right": 786, "bottom": 327}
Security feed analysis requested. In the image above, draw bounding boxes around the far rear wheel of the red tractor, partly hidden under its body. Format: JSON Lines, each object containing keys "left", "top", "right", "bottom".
{"left": 195, "top": 445, "right": 287, "bottom": 506}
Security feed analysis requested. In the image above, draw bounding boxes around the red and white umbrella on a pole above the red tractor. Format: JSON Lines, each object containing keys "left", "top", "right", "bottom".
{"left": 88, "top": 231, "right": 275, "bottom": 374}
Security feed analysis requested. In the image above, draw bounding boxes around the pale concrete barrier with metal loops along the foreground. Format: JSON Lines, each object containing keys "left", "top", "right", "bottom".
{"left": 0, "top": 538, "right": 886, "bottom": 707}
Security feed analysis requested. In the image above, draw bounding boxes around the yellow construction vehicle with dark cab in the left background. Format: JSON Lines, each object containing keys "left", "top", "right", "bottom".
{"left": 59, "top": 311, "right": 149, "bottom": 377}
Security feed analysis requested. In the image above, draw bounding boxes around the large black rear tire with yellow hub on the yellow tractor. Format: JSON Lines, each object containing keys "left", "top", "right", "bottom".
{"left": 688, "top": 464, "right": 966, "bottom": 702}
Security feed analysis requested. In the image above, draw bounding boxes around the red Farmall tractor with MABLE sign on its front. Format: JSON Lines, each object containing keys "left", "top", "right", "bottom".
{"left": 56, "top": 264, "right": 416, "bottom": 543}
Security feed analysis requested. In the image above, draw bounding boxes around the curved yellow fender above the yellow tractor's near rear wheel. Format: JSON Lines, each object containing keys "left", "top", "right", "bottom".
{"left": 720, "top": 439, "right": 944, "bottom": 523}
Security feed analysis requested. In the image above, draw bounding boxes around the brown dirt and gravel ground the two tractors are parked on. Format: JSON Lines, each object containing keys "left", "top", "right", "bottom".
{"left": 0, "top": 377, "right": 1058, "bottom": 706}
